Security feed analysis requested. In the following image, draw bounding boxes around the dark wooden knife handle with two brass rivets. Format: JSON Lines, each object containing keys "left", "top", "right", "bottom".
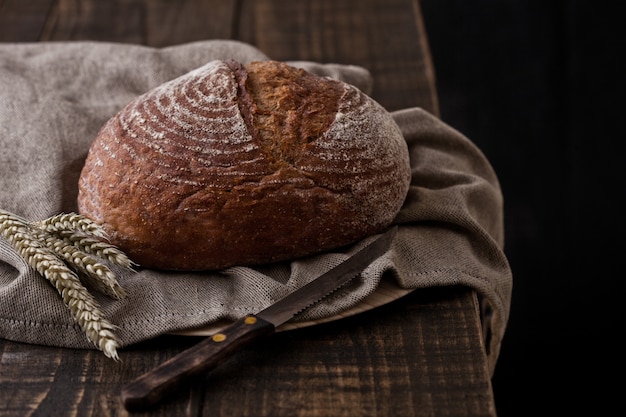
{"left": 122, "top": 316, "right": 276, "bottom": 411}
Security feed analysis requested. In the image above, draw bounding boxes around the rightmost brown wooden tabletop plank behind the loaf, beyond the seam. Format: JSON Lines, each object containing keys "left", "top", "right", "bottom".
{"left": 237, "top": 0, "right": 439, "bottom": 114}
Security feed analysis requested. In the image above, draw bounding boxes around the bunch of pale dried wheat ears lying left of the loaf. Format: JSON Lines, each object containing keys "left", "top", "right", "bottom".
{"left": 0, "top": 209, "right": 134, "bottom": 360}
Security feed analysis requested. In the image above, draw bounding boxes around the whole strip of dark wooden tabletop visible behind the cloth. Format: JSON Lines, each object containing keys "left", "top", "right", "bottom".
{"left": 0, "top": 0, "right": 439, "bottom": 114}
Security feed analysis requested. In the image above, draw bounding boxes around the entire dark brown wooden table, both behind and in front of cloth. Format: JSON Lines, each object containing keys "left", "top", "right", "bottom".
{"left": 0, "top": 0, "right": 496, "bottom": 417}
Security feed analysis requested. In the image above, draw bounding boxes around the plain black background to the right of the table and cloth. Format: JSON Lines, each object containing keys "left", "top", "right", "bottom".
{"left": 421, "top": 0, "right": 626, "bottom": 417}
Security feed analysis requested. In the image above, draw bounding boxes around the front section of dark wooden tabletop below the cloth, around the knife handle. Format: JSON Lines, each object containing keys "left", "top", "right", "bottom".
{"left": 0, "top": 288, "right": 495, "bottom": 417}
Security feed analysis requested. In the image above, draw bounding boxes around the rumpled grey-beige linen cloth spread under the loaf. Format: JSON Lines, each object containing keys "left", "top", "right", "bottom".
{"left": 0, "top": 40, "right": 512, "bottom": 372}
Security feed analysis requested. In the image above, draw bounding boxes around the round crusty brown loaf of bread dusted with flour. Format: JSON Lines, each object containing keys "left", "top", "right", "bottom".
{"left": 78, "top": 61, "right": 411, "bottom": 271}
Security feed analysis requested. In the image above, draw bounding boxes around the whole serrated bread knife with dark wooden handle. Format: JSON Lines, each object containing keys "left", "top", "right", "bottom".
{"left": 122, "top": 226, "right": 398, "bottom": 411}
